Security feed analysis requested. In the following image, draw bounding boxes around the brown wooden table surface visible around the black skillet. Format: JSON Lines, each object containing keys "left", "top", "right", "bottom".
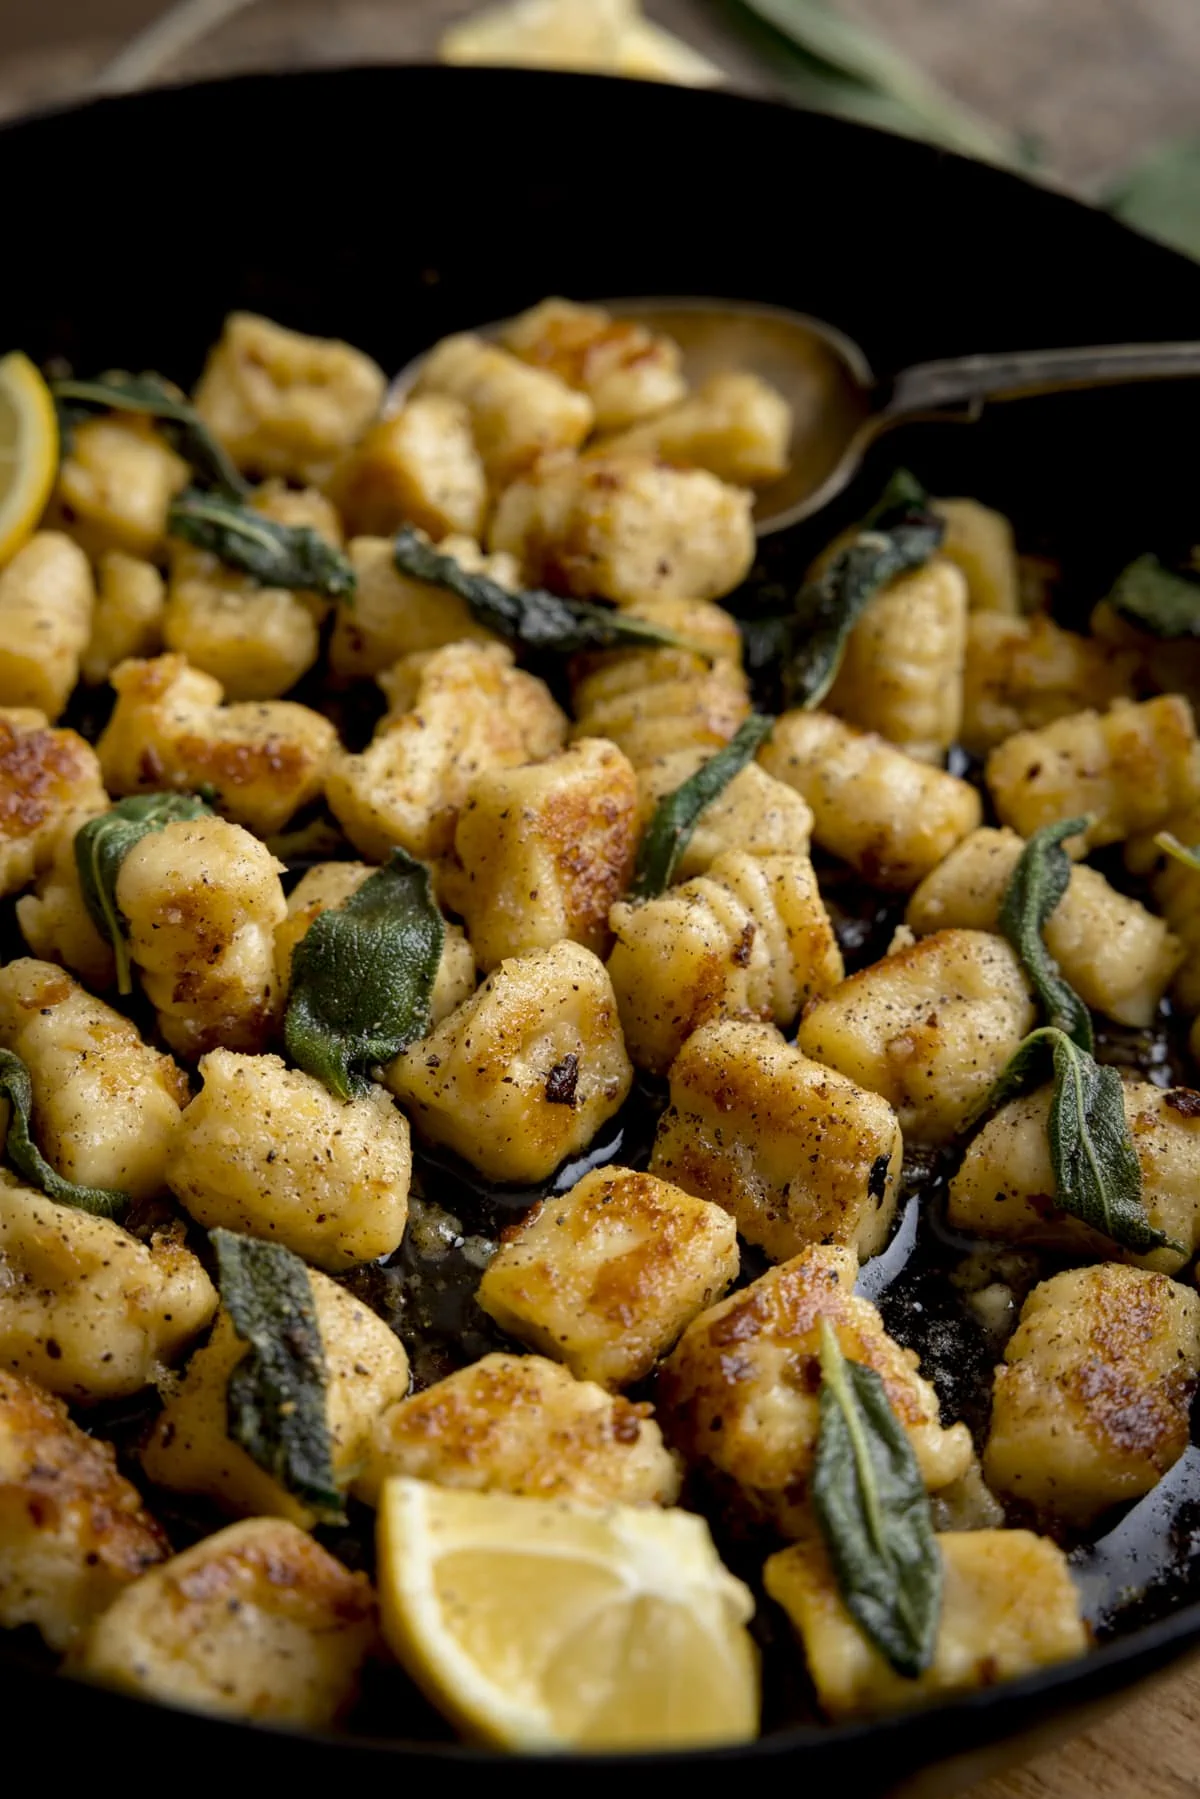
{"left": 0, "top": 0, "right": 1200, "bottom": 1799}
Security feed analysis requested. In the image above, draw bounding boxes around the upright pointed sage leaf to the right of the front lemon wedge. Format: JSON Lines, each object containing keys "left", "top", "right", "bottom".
{"left": 811, "top": 1319, "right": 943, "bottom": 1678}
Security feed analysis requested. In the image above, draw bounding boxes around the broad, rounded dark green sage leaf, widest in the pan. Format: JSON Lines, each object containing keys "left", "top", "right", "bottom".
{"left": 284, "top": 849, "right": 446, "bottom": 1099}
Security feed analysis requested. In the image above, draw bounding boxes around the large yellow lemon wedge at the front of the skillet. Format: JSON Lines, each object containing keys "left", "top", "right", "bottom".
{"left": 378, "top": 1479, "right": 759, "bottom": 1749}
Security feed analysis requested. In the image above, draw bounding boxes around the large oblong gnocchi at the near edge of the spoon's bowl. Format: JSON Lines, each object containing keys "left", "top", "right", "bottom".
{"left": 488, "top": 453, "right": 754, "bottom": 606}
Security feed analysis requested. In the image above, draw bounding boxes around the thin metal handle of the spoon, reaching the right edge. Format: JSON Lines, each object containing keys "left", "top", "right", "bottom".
{"left": 882, "top": 344, "right": 1200, "bottom": 425}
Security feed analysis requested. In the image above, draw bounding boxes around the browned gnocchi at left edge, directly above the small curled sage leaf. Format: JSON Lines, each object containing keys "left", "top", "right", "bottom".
{"left": 0, "top": 955, "right": 187, "bottom": 1200}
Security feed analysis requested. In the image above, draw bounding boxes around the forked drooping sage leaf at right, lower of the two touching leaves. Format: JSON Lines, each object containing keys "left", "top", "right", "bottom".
{"left": 986, "top": 1025, "right": 1182, "bottom": 1256}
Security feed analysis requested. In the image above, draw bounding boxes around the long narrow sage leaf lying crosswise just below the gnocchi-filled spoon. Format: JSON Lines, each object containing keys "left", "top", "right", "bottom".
{"left": 392, "top": 525, "right": 684, "bottom": 655}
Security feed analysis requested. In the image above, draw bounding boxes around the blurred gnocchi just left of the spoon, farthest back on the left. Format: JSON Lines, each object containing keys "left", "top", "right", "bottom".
{"left": 196, "top": 313, "right": 387, "bottom": 488}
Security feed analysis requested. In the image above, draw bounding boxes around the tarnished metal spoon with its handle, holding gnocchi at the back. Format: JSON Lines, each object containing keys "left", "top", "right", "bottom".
{"left": 389, "top": 299, "right": 1200, "bottom": 536}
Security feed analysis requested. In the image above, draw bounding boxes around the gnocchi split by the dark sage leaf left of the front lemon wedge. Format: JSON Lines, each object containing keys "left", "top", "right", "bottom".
{"left": 142, "top": 1268, "right": 408, "bottom": 1529}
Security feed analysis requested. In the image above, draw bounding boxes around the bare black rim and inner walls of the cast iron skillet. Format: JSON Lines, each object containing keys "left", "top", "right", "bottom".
{"left": 0, "top": 68, "right": 1200, "bottom": 1795}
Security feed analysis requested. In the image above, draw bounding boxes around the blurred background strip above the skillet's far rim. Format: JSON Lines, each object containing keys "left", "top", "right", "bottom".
{"left": 0, "top": 0, "right": 1200, "bottom": 205}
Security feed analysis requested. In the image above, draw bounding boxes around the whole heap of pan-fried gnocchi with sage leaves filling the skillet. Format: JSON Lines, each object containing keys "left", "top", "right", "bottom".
{"left": 0, "top": 299, "right": 1200, "bottom": 1749}
